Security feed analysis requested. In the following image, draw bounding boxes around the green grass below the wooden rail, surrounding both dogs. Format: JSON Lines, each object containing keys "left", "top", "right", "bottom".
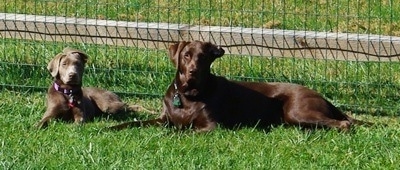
{"left": 0, "top": 40, "right": 400, "bottom": 169}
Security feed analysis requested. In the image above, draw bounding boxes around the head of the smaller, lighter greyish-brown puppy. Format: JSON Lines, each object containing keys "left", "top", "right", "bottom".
{"left": 47, "top": 48, "right": 88, "bottom": 85}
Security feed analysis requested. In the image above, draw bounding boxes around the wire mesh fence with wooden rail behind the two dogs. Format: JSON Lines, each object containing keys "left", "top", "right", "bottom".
{"left": 0, "top": 0, "right": 400, "bottom": 115}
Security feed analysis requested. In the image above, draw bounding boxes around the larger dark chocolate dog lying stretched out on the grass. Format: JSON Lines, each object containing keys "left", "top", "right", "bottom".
{"left": 110, "top": 41, "right": 367, "bottom": 132}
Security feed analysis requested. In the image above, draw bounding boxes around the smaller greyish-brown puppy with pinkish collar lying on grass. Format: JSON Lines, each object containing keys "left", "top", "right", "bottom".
{"left": 37, "top": 48, "right": 151, "bottom": 128}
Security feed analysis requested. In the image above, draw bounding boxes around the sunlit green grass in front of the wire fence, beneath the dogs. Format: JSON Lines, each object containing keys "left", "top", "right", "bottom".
{"left": 0, "top": 90, "right": 400, "bottom": 169}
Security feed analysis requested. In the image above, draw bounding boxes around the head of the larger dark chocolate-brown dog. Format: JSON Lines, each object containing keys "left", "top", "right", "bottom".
{"left": 169, "top": 41, "right": 225, "bottom": 95}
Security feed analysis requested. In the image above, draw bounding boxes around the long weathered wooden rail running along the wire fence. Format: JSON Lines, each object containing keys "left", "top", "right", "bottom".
{"left": 0, "top": 13, "right": 400, "bottom": 61}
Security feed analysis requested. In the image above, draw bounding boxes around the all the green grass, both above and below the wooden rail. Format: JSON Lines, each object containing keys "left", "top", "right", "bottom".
{"left": 0, "top": 0, "right": 400, "bottom": 169}
